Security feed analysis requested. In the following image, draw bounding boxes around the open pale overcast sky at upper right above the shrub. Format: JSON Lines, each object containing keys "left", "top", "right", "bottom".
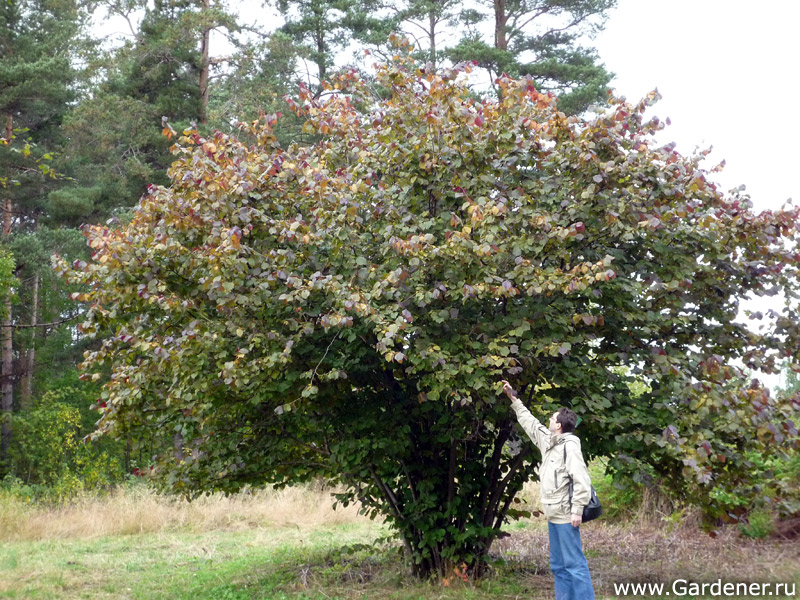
{"left": 594, "top": 0, "right": 800, "bottom": 210}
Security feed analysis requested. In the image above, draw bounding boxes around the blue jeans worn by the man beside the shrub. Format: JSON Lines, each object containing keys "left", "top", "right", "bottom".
{"left": 547, "top": 522, "right": 594, "bottom": 600}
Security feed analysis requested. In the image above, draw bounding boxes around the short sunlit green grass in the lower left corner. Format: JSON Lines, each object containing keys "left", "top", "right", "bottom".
{"left": 0, "top": 525, "right": 388, "bottom": 600}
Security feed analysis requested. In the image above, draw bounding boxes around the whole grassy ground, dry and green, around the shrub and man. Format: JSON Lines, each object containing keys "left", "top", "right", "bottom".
{"left": 0, "top": 488, "right": 800, "bottom": 600}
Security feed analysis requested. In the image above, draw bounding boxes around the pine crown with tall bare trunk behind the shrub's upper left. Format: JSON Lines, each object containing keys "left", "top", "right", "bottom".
{"left": 50, "top": 0, "right": 238, "bottom": 220}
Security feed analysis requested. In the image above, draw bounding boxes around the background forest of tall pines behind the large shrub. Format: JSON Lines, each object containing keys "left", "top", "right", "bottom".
{"left": 0, "top": 0, "right": 613, "bottom": 494}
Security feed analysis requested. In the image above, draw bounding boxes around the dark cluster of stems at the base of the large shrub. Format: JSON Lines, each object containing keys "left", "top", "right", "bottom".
{"left": 324, "top": 398, "right": 534, "bottom": 578}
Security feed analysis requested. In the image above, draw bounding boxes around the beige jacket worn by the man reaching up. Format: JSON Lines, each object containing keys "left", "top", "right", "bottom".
{"left": 511, "top": 398, "right": 592, "bottom": 523}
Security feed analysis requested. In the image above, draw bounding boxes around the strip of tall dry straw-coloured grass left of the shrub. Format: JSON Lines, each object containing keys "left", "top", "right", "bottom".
{"left": 0, "top": 486, "right": 367, "bottom": 541}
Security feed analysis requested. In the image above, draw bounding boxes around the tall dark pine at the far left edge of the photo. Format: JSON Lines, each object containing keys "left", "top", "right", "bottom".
{"left": 0, "top": 0, "right": 85, "bottom": 462}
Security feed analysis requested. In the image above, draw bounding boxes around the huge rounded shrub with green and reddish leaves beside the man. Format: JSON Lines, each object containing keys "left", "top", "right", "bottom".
{"left": 60, "top": 60, "right": 800, "bottom": 575}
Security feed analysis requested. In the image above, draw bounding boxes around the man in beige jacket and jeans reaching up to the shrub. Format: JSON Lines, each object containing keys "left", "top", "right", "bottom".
{"left": 502, "top": 380, "right": 594, "bottom": 600}
